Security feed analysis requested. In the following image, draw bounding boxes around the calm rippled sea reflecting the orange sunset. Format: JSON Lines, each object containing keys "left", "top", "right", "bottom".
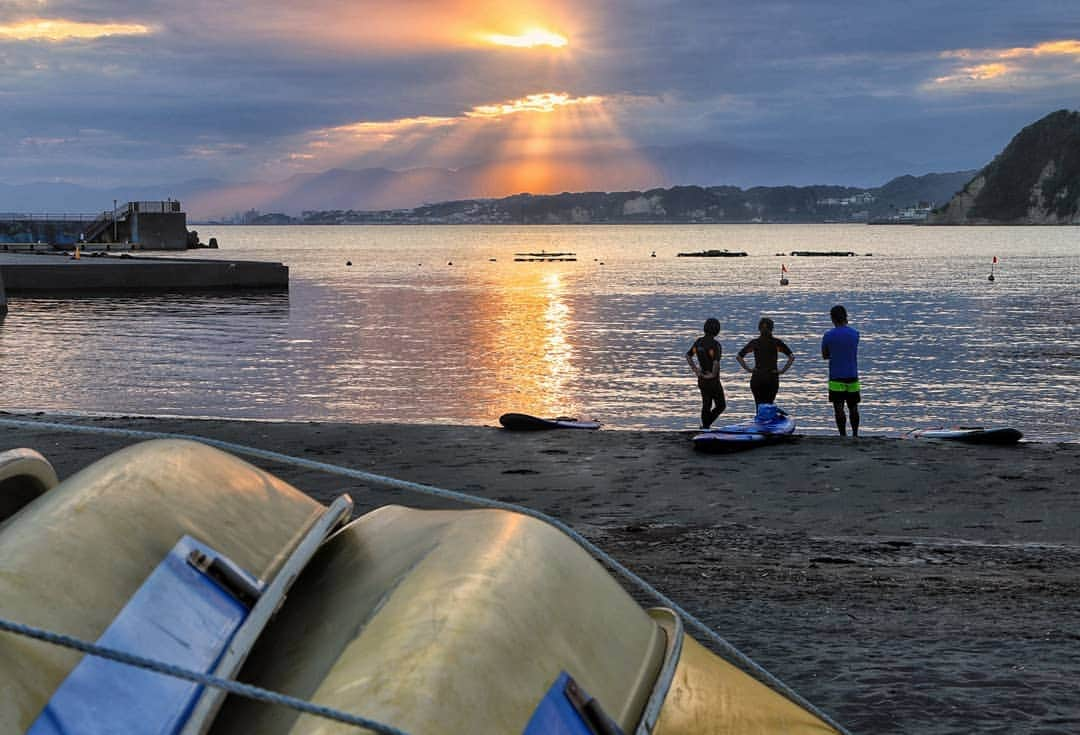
{"left": 0, "top": 226, "right": 1080, "bottom": 440}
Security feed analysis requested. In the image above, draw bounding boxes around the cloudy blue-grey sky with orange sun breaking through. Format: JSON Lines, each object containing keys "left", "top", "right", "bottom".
{"left": 0, "top": 0, "right": 1080, "bottom": 200}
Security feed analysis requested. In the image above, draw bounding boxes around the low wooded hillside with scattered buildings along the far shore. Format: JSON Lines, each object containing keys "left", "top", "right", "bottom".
{"left": 295, "top": 172, "right": 974, "bottom": 224}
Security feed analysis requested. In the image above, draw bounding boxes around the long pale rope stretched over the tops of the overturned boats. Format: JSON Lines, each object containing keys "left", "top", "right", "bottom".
{"left": 0, "top": 419, "right": 850, "bottom": 735}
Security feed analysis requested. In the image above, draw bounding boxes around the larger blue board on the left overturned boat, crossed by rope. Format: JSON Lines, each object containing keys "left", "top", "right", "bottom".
{"left": 27, "top": 536, "right": 248, "bottom": 735}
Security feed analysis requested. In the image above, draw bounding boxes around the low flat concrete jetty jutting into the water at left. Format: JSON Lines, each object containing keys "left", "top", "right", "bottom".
{"left": 0, "top": 253, "right": 288, "bottom": 294}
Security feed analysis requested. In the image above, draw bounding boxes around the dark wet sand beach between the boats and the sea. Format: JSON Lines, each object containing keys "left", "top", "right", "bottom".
{"left": 0, "top": 416, "right": 1080, "bottom": 734}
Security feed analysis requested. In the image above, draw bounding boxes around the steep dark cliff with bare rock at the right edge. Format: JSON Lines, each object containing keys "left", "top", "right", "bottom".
{"left": 928, "top": 110, "right": 1080, "bottom": 224}
